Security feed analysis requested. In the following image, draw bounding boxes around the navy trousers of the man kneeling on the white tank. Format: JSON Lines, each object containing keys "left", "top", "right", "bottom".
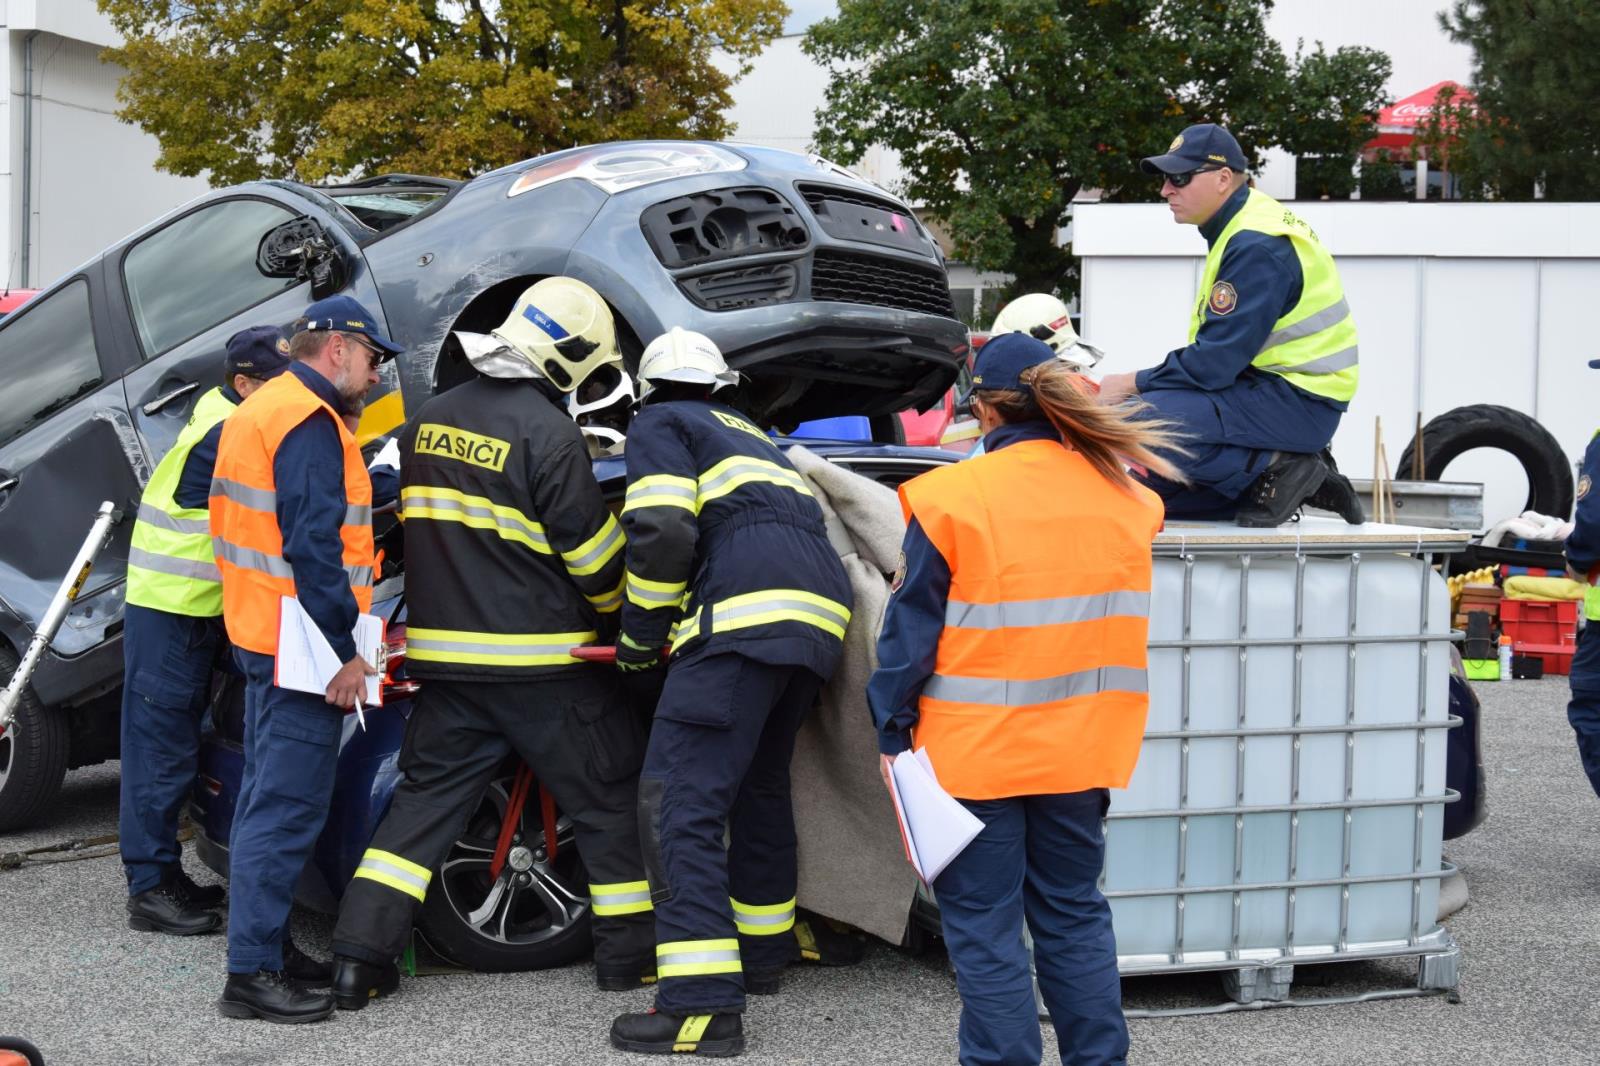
{"left": 1139, "top": 373, "right": 1339, "bottom": 519}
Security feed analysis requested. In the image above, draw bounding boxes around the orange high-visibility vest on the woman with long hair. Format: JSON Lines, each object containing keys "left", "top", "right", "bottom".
{"left": 899, "top": 440, "right": 1162, "bottom": 800}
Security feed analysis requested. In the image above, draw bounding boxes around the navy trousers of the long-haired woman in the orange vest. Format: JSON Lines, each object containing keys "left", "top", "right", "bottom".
{"left": 933, "top": 789, "right": 1128, "bottom": 1066}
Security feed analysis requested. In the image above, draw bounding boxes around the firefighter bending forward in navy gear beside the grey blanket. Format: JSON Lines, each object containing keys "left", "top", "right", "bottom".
{"left": 611, "top": 330, "right": 851, "bottom": 1055}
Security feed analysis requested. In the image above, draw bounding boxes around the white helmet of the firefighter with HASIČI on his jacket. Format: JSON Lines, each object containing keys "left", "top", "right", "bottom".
{"left": 494, "top": 277, "right": 622, "bottom": 392}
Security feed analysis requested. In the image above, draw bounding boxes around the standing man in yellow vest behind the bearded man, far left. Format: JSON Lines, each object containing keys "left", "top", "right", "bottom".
{"left": 120, "top": 327, "right": 290, "bottom": 936}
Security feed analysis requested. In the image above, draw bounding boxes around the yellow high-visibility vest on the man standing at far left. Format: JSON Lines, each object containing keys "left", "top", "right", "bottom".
{"left": 128, "top": 389, "right": 238, "bottom": 618}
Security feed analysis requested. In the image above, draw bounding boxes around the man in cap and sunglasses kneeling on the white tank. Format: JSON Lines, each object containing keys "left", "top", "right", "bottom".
{"left": 1101, "top": 123, "right": 1363, "bottom": 527}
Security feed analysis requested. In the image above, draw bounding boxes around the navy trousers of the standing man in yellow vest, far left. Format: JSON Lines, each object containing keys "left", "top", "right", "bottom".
{"left": 118, "top": 603, "right": 224, "bottom": 895}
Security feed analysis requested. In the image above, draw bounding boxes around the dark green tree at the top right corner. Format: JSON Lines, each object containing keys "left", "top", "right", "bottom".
{"left": 1426, "top": 0, "right": 1600, "bottom": 200}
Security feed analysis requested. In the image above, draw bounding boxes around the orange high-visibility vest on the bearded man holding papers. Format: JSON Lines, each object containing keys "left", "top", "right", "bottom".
{"left": 211, "top": 373, "right": 374, "bottom": 655}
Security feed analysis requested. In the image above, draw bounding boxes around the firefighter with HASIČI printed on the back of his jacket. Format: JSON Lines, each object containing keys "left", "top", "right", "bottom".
{"left": 333, "top": 277, "right": 654, "bottom": 1010}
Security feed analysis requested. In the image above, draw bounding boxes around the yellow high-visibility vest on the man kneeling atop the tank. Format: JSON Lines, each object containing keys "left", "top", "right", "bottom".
{"left": 1189, "top": 189, "right": 1360, "bottom": 403}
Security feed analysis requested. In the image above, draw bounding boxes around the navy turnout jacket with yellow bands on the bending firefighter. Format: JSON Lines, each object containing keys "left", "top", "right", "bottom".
{"left": 622, "top": 400, "right": 851, "bottom": 677}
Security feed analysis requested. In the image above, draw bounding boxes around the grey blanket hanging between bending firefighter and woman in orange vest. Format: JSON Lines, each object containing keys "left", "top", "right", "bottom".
{"left": 789, "top": 447, "right": 917, "bottom": 944}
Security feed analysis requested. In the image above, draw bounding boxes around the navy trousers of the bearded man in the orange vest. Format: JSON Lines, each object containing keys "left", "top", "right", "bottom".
{"left": 227, "top": 648, "right": 346, "bottom": 973}
